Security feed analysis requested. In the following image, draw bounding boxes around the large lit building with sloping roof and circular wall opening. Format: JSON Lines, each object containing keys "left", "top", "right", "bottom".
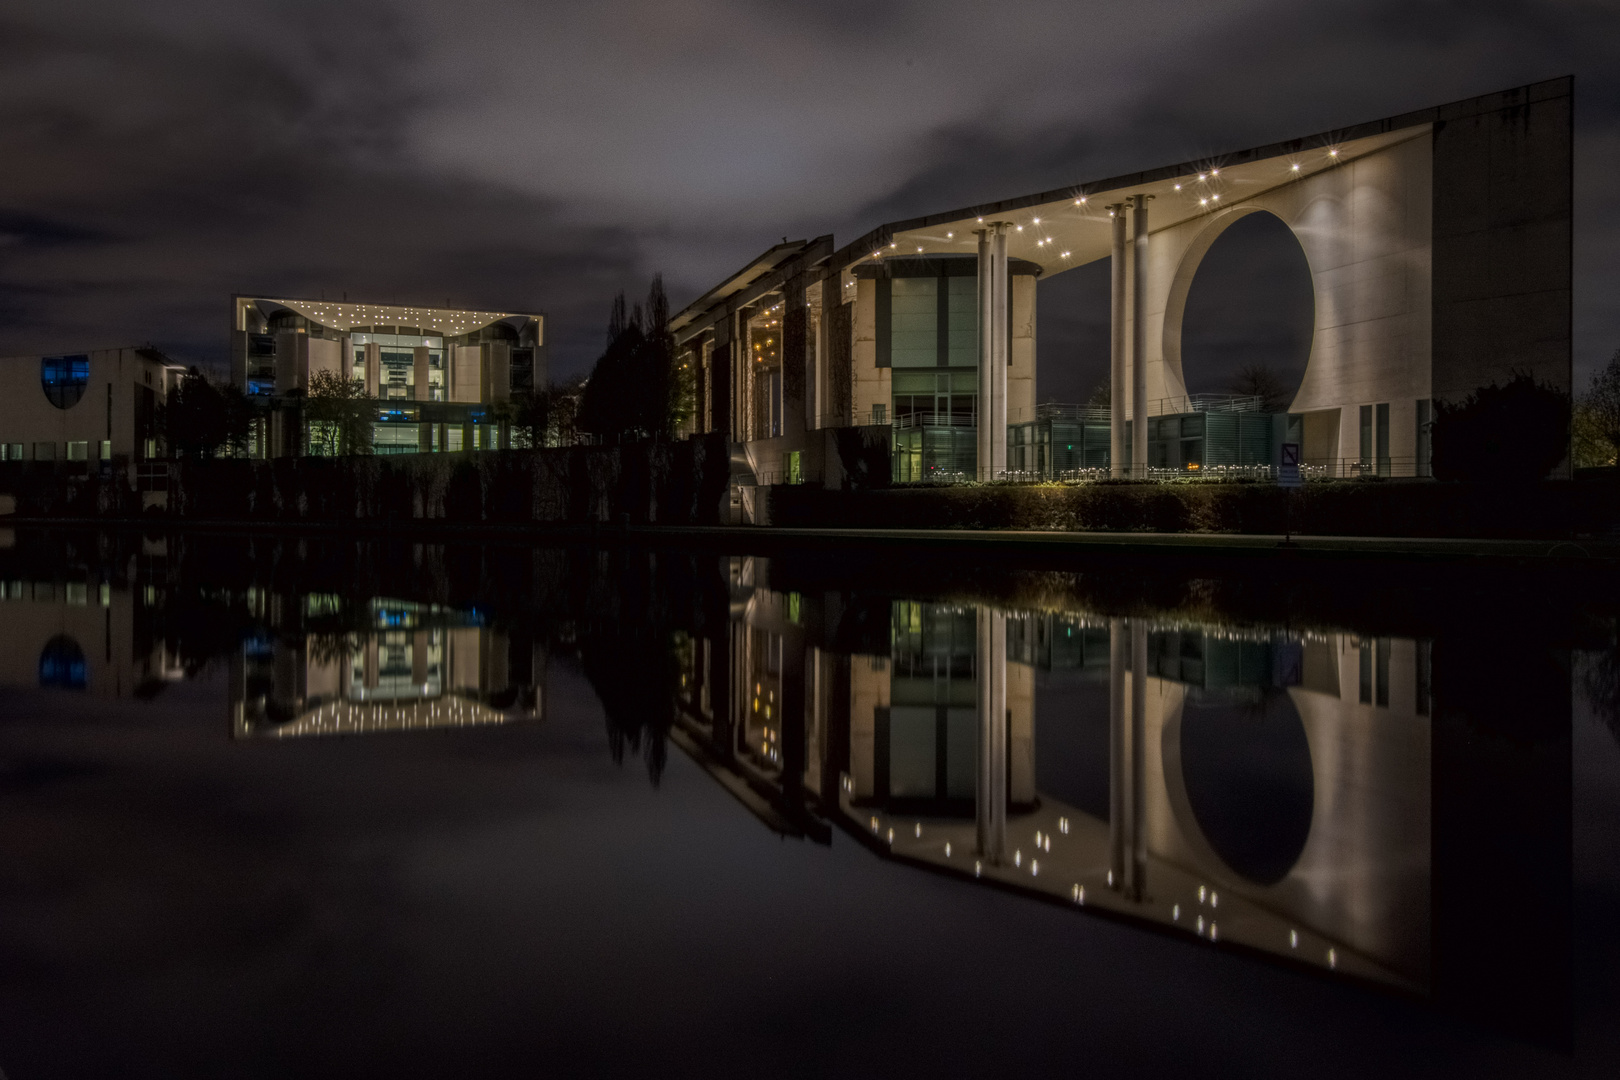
{"left": 672, "top": 78, "right": 1573, "bottom": 520}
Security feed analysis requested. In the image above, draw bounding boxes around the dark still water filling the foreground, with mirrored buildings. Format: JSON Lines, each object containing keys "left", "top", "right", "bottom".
{"left": 0, "top": 533, "right": 1620, "bottom": 1080}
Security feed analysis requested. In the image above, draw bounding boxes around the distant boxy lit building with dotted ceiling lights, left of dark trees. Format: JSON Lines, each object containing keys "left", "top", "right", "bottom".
{"left": 230, "top": 295, "right": 546, "bottom": 457}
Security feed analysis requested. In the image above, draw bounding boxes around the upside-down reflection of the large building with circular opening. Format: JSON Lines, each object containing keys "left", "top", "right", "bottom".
{"left": 672, "top": 559, "right": 1430, "bottom": 991}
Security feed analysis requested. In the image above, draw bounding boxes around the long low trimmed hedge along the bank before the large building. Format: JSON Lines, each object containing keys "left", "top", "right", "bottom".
{"left": 768, "top": 481, "right": 1620, "bottom": 539}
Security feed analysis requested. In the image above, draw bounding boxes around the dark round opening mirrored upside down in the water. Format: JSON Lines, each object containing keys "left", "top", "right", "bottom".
{"left": 1181, "top": 688, "right": 1315, "bottom": 886}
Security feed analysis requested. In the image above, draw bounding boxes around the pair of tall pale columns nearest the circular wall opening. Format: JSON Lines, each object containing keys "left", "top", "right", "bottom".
{"left": 1108, "top": 194, "right": 1153, "bottom": 478}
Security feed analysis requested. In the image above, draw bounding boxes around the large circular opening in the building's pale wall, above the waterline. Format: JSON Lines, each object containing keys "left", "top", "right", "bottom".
{"left": 1181, "top": 210, "right": 1315, "bottom": 413}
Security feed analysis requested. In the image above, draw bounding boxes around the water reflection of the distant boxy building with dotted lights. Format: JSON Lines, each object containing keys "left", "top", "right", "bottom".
{"left": 230, "top": 593, "right": 546, "bottom": 738}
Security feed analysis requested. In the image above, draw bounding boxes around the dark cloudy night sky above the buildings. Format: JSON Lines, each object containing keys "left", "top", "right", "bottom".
{"left": 0, "top": 0, "right": 1620, "bottom": 398}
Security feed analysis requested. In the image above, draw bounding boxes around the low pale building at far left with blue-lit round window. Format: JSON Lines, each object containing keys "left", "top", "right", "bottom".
{"left": 0, "top": 348, "right": 185, "bottom": 468}
